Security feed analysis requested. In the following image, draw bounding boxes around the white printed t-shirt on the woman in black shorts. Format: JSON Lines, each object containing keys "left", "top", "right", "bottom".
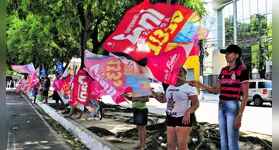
{"left": 166, "top": 83, "right": 197, "bottom": 117}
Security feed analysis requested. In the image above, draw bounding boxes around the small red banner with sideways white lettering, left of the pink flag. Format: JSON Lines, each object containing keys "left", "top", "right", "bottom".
{"left": 68, "top": 69, "right": 92, "bottom": 110}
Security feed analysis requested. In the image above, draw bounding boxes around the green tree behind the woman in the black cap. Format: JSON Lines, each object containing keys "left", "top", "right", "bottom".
{"left": 225, "top": 14, "right": 272, "bottom": 78}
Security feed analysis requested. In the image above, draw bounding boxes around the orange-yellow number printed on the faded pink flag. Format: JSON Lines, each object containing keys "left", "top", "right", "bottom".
{"left": 106, "top": 60, "right": 122, "bottom": 87}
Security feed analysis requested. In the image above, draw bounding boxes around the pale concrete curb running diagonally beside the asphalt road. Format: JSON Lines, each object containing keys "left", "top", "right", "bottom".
{"left": 25, "top": 95, "right": 119, "bottom": 150}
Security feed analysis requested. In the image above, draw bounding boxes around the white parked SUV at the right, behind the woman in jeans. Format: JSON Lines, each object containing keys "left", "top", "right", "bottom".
{"left": 247, "top": 79, "right": 272, "bottom": 106}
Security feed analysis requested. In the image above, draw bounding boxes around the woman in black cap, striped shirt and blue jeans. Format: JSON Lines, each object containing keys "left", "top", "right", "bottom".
{"left": 188, "top": 44, "right": 249, "bottom": 150}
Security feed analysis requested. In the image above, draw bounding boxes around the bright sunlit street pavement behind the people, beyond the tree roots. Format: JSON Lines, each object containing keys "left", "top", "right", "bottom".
{"left": 100, "top": 93, "right": 272, "bottom": 135}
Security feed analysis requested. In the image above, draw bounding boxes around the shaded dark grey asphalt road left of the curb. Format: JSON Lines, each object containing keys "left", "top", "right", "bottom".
{"left": 6, "top": 92, "right": 71, "bottom": 150}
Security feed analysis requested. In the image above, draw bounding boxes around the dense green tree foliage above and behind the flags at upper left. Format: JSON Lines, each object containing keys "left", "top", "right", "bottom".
{"left": 6, "top": 0, "right": 206, "bottom": 71}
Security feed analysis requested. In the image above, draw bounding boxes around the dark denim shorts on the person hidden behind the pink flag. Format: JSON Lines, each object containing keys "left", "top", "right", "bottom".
{"left": 133, "top": 108, "right": 148, "bottom": 126}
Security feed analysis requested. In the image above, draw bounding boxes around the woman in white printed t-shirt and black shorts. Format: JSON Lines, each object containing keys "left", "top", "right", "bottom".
{"left": 152, "top": 68, "right": 199, "bottom": 150}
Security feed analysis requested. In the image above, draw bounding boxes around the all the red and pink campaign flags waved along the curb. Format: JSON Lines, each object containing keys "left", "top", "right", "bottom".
{"left": 12, "top": 0, "right": 215, "bottom": 114}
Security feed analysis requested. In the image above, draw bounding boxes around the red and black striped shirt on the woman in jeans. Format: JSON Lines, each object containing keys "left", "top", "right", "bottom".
{"left": 218, "top": 66, "right": 249, "bottom": 101}
